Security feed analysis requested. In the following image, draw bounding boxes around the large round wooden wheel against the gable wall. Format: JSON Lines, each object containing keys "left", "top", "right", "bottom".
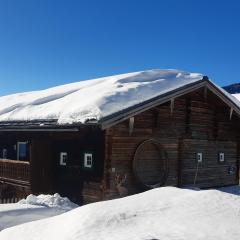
{"left": 133, "top": 139, "right": 168, "bottom": 189}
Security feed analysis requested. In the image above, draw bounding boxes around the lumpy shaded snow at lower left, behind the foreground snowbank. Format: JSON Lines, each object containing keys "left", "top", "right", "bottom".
{"left": 0, "top": 194, "right": 78, "bottom": 231}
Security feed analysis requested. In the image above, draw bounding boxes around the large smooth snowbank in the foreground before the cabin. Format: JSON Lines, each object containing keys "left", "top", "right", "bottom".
{"left": 0, "top": 187, "right": 240, "bottom": 240}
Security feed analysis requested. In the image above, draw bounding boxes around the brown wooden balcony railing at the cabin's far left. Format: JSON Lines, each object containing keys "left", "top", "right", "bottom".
{"left": 0, "top": 159, "right": 30, "bottom": 182}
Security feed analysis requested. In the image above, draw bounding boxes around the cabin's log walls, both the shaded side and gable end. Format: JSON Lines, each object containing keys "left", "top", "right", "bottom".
{"left": 0, "top": 89, "right": 240, "bottom": 203}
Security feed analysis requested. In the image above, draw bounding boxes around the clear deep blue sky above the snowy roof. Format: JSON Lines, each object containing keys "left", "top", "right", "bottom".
{"left": 0, "top": 0, "right": 240, "bottom": 95}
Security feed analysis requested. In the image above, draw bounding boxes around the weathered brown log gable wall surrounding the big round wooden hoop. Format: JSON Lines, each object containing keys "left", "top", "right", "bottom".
{"left": 105, "top": 89, "right": 239, "bottom": 197}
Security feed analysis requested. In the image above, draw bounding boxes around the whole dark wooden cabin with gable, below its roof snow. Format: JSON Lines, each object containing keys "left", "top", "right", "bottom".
{"left": 0, "top": 70, "right": 240, "bottom": 203}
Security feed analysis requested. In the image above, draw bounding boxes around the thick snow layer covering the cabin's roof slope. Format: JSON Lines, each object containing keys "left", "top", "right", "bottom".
{"left": 0, "top": 69, "right": 203, "bottom": 124}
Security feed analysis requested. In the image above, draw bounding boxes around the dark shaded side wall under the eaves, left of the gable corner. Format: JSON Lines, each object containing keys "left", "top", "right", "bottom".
{"left": 0, "top": 127, "right": 104, "bottom": 203}
